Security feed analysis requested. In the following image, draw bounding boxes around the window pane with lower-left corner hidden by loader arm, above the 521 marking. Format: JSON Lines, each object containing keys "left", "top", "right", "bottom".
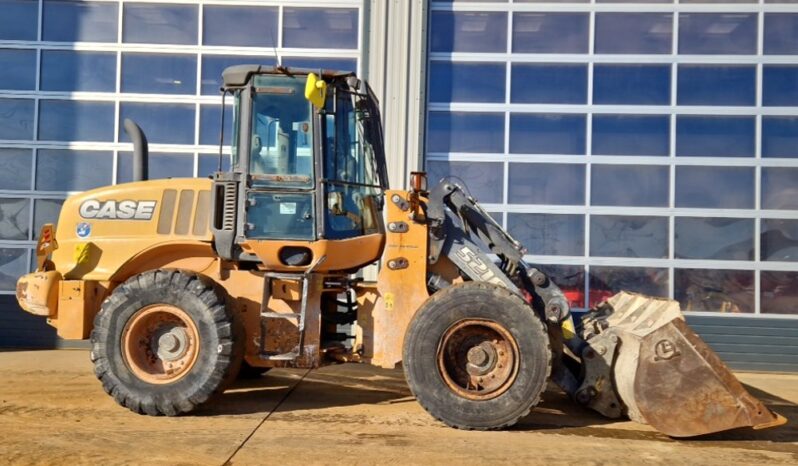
{"left": 507, "top": 214, "right": 585, "bottom": 256}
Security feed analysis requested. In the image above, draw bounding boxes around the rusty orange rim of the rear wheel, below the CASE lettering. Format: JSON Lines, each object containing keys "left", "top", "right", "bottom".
{"left": 122, "top": 304, "right": 199, "bottom": 384}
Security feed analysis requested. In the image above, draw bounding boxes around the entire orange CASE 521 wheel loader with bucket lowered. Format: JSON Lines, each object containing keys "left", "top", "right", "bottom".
{"left": 16, "top": 65, "right": 785, "bottom": 437}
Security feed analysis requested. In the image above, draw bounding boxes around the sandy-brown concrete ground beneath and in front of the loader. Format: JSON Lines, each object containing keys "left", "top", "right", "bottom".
{"left": 0, "top": 350, "right": 798, "bottom": 466}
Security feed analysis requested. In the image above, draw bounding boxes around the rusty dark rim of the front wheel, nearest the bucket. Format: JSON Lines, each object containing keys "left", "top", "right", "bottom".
{"left": 437, "top": 319, "right": 519, "bottom": 400}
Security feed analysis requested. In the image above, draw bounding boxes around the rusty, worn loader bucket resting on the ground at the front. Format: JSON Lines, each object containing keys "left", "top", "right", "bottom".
{"left": 581, "top": 292, "right": 786, "bottom": 437}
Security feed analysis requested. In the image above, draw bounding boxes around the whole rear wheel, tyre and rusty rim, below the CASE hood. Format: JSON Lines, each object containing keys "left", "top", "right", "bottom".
{"left": 91, "top": 270, "right": 243, "bottom": 416}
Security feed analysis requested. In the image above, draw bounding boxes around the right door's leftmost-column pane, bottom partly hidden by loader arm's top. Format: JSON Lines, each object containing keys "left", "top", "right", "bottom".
{"left": 427, "top": 161, "right": 504, "bottom": 203}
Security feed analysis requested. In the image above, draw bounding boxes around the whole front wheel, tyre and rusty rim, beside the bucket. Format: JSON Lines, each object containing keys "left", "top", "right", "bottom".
{"left": 403, "top": 282, "right": 551, "bottom": 430}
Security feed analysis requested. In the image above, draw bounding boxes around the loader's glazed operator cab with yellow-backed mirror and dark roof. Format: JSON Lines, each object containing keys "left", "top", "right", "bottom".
{"left": 212, "top": 65, "right": 387, "bottom": 271}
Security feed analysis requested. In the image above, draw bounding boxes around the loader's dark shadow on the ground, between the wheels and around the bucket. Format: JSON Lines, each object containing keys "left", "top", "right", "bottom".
{"left": 195, "top": 364, "right": 798, "bottom": 452}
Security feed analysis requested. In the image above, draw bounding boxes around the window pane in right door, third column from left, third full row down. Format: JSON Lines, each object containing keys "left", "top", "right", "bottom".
{"left": 593, "top": 115, "right": 671, "bottom": 155}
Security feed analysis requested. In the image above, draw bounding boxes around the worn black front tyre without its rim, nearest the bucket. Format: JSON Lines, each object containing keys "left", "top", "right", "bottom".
{"left": 403, "top": 282, "right": 551, "bottom": 430}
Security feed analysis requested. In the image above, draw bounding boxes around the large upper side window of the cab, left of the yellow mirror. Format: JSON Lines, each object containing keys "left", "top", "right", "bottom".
{"left": 249, "top": 75, "right": 313, "bottom": 188}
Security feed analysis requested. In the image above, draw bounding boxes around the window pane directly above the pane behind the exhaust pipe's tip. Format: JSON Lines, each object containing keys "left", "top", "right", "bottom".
{"left": 122, "top": 53, "right": 197, "bottom": 94}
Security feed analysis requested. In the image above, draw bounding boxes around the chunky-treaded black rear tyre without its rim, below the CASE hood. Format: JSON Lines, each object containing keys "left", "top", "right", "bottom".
{"left": 91, "top": 270, "right": 243, "bottom": 416}
